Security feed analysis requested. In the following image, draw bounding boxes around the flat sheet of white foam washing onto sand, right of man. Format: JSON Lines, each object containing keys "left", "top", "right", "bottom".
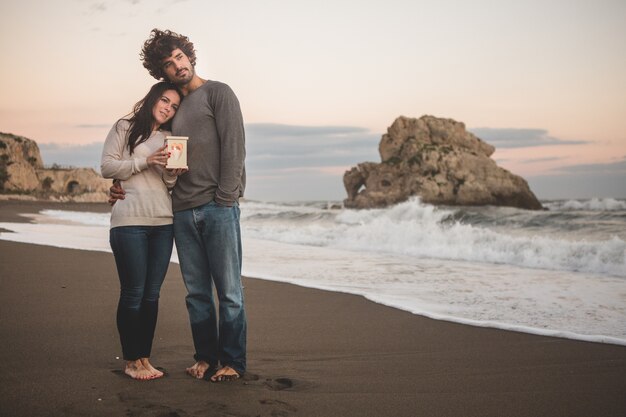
{"left": 244, "top": 239, "right": 626, "bottom": 345}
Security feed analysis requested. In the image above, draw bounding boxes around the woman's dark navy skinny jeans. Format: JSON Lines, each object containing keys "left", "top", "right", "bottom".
{"left": 109, "top": 224, "right": 174, "bottom": 361}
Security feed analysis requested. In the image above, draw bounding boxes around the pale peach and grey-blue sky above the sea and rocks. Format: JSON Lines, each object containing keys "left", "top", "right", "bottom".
{"left": 0, "top": 0, "right": 626, "bottom": 201}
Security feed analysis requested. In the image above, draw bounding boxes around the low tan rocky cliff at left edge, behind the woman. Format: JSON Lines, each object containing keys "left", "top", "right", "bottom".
{"left": 0, "top": 133, "right": 110, "bottom": 202}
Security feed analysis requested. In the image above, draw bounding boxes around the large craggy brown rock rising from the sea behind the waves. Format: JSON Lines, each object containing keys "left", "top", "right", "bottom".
{"left": 343, "top": 116, "right": 542, "bottom": 210}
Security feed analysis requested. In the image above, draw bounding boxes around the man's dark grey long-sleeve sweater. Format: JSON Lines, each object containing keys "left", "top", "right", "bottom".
{"left": 172, "top": 80, "right": 246, "bottom": 211}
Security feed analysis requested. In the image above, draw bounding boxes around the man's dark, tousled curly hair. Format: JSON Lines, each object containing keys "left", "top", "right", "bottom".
{"left": 139, "top": 29, "right": 196, "bottom": 80}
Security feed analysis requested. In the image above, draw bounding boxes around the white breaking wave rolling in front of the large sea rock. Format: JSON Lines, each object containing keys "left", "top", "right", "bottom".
{"left": 242, "top": 198, "right": 626, "bottom": 277}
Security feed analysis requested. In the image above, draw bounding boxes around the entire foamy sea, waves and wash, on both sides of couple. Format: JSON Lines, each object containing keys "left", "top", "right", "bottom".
{"left": 0, "top": 199, "right": 626, "bottom": 345}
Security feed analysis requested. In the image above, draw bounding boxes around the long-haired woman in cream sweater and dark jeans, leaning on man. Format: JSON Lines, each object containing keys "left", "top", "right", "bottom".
{"left": 100, "top": 82, "right": 182, "bottom": 380}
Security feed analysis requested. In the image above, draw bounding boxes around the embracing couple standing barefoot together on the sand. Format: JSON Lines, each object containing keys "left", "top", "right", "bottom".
{"left": 101, "top": 29, "right": 246, "bottom": 382}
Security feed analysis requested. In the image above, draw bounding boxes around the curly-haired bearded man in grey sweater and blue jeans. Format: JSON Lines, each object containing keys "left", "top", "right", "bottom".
{"left": 110, "top": 29, "right": 247, "bottom": 382}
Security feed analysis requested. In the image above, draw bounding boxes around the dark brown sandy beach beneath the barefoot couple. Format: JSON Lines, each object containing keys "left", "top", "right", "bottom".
{"left": 0, "top": 201, "right": 626, "bottom": 417}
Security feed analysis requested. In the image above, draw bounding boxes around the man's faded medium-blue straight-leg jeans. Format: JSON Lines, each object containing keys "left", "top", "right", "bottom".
{"left": 174, "top": 201, "right": 247, "bottom": 374}
